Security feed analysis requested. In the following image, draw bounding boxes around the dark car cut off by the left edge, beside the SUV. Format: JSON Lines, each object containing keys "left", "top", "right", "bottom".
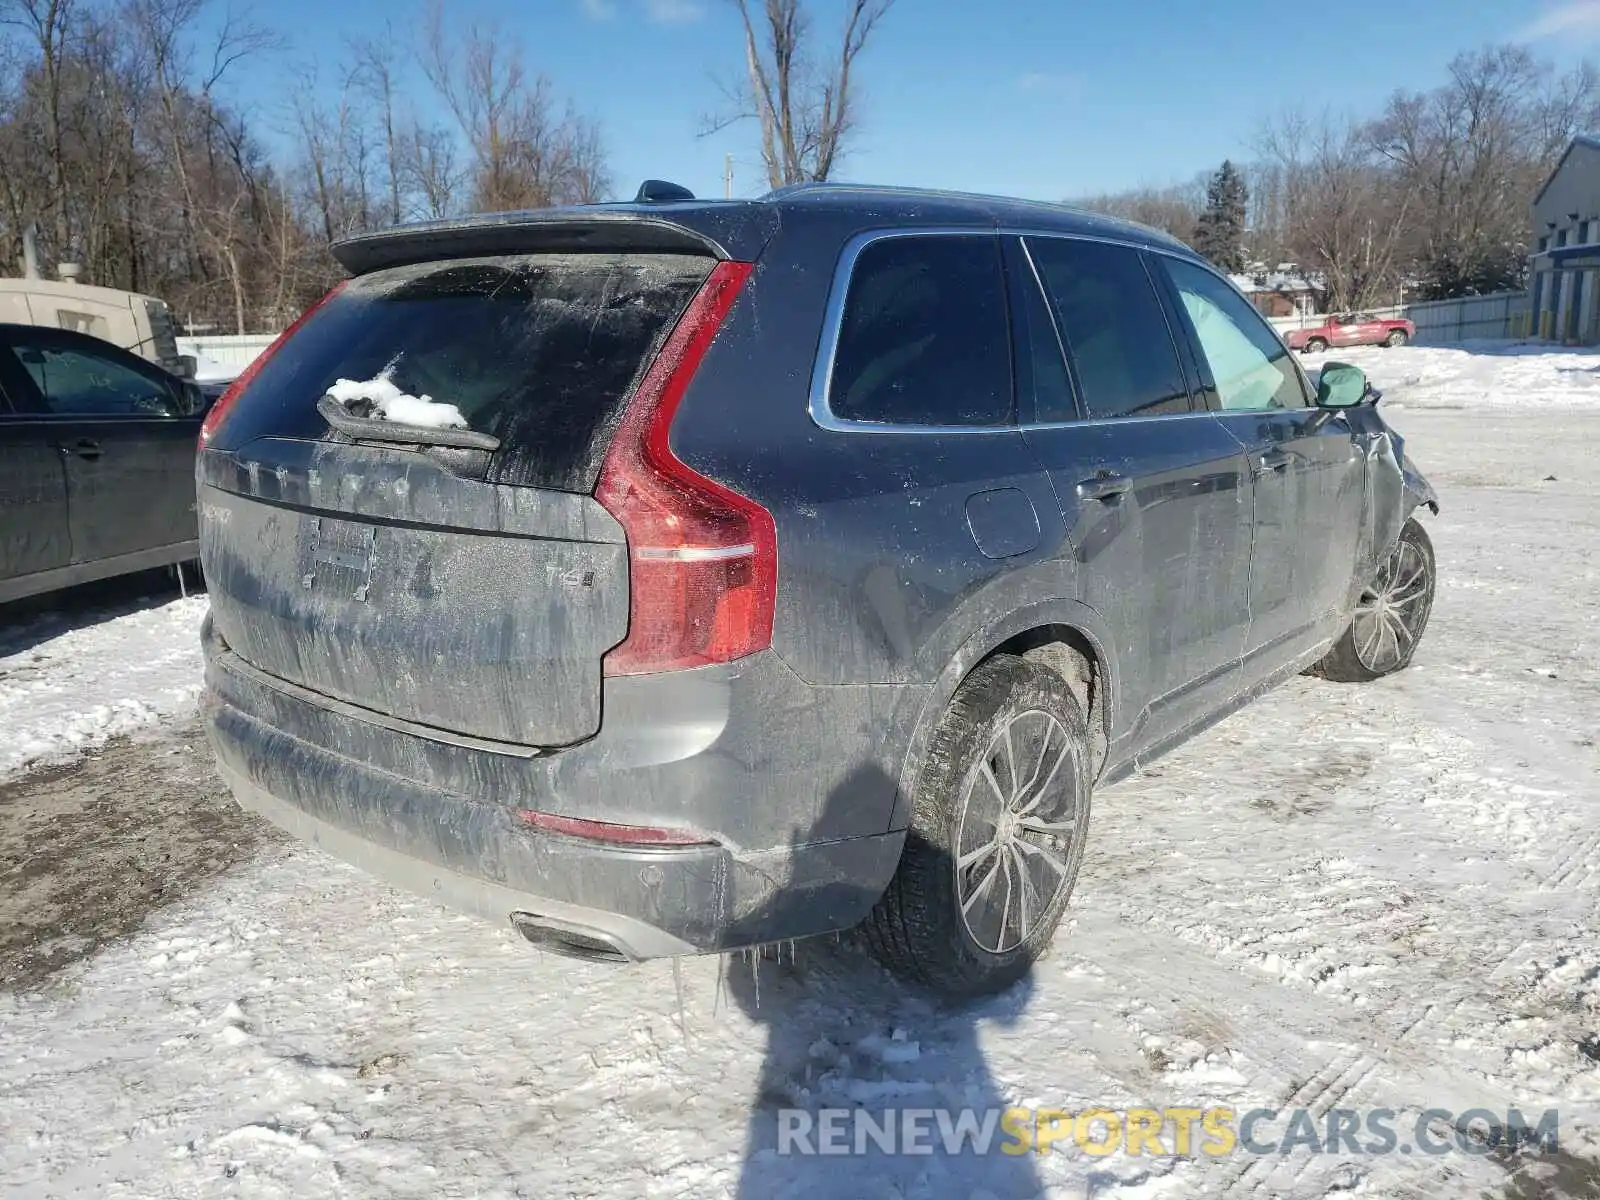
{"left": 0, "top": 325, "right": 208, "bottom": 602}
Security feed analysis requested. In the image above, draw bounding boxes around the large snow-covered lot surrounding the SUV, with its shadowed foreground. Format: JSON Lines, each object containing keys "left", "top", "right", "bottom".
{"left": 0, "top": 349, "right": 1600, "bottom": 1200}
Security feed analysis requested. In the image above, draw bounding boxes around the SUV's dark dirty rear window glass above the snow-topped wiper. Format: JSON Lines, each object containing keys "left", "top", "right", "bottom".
{"left": 214, "top": 254, "right": 712, "bottom": 491}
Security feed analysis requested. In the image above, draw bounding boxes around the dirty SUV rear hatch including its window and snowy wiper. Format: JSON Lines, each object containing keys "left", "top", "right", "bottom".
{"left": 200, "top": 253, "right": 715, "bottom": 746}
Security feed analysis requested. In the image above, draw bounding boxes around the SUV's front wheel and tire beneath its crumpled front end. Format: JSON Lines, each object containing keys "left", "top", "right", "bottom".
{"left": 1307, "top": 518, "right": 1438, "bottom": 683}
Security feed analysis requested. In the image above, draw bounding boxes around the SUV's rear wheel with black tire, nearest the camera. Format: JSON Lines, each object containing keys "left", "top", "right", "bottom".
{"left": 862, "top": 654, "right": 1091, "bottom": 997}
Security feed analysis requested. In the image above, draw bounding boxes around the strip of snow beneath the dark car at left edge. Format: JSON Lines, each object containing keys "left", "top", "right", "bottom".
{"left": 0, "top": 597, "right": 206, "bottom": 778}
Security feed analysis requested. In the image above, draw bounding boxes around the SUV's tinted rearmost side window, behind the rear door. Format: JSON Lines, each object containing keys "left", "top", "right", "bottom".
{"left": 829, "top": 235, "right": 1014, "bottom": 426}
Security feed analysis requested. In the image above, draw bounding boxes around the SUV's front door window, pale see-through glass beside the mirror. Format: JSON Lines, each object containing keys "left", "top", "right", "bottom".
{"left": 1165, "top": 259, "right": 1307, "bottom": 410}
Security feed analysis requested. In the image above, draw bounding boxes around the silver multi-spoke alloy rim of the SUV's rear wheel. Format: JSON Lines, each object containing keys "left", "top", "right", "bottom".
{"left": 955, "top": 709, "right": 1078, "bottom": 954}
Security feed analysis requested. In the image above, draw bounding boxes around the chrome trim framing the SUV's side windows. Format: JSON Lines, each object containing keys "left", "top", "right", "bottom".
{"left": 808, "top": 226, "right": 1235, "bottom": 435}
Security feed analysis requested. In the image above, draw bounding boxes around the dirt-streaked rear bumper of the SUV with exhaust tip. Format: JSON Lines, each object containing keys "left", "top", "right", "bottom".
{"left": 203, "top": 638, "right": 904, "bottom": 960}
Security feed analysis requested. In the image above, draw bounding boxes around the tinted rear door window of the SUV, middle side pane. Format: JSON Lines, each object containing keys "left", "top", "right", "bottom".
{"left": 1027, "top": 238, "right": 1189, "bottom": 418}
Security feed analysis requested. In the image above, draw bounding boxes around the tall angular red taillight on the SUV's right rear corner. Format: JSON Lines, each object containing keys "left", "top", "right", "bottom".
{"left": 595, "top": 262, "right": 778, "bottom": 675}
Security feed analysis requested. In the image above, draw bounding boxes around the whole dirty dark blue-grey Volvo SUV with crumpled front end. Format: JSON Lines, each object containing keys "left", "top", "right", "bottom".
{"left": 198, "top": 186, "right": 1434, "bottom": 992}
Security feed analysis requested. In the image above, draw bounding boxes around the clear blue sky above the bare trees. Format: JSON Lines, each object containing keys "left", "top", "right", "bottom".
{"left": 237, "top": 0, "right": 1600, "bottom": 200}
